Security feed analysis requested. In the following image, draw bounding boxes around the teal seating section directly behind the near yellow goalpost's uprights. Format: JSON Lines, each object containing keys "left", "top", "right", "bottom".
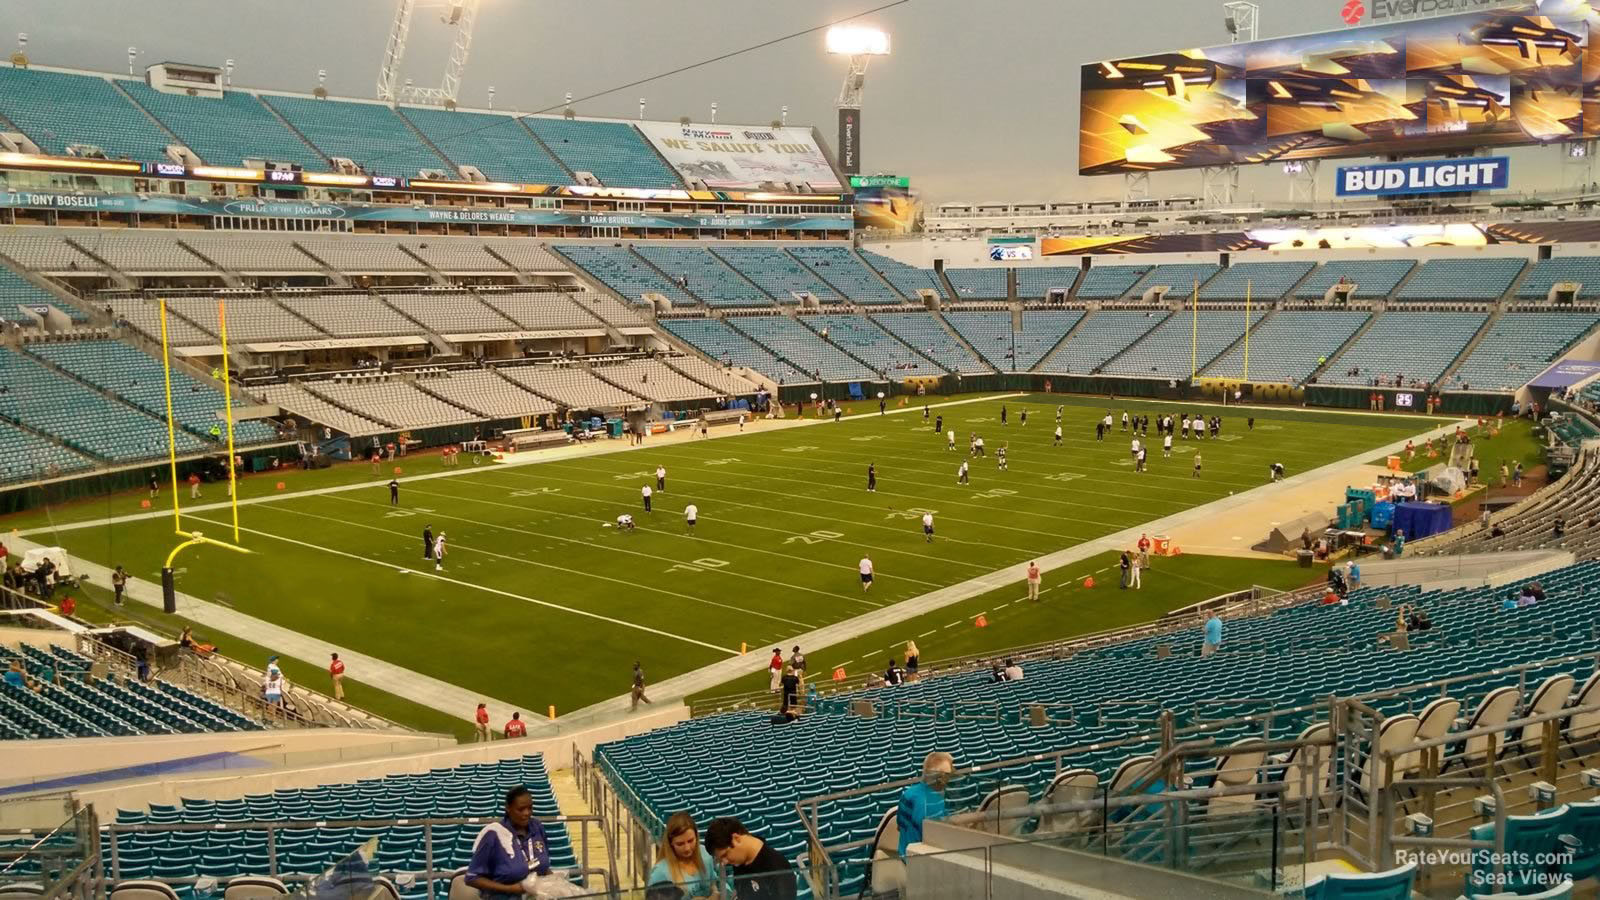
{"left": 26, "top": 341, "right": 277, "bottom": 444}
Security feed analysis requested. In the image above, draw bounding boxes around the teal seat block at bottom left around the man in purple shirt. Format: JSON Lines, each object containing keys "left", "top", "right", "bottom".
{"left": 104, "top": 754, "right": 579, "bottom": 898}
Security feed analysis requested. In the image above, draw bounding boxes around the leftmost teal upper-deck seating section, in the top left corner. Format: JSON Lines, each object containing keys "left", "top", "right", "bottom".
{"left": 0, "top": 67, "right": 178, "bottom": 160}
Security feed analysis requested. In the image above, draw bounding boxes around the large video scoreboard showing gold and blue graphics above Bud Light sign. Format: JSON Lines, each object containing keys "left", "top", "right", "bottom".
{"left": 1078, "top": 0, "right": 1600, "bottom": 175}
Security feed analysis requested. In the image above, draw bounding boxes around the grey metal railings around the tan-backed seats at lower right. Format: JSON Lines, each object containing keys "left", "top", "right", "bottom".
{"left": 795, "top": 650, "right": 1600, "bottom": 895}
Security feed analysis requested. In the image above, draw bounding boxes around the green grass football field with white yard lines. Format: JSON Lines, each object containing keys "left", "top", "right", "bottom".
{"left": 0, "top": 396, "right": 1443, "bottom": 719}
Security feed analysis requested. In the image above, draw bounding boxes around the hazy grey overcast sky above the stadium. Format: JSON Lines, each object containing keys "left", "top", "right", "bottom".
{"left": 0, "top": 0, "right": 1560, "bottom": 203}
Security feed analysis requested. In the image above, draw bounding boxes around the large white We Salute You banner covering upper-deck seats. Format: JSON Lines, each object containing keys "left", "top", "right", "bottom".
{"left": 638, "top": 122, "right": 842, "bottom": 191}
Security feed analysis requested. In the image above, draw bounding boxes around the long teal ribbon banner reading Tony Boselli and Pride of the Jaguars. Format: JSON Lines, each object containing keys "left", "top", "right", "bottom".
{"left": 0, "top": 191, "right": 851, "bottom": 231}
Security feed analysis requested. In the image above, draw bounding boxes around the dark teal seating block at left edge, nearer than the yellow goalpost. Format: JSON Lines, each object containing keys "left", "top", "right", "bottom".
{"left": 0, "top": 644, "right": 261, "bottom": 740}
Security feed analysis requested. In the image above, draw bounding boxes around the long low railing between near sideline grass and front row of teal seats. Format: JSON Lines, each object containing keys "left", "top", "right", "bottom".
{"left": 690, "top": 585, "right": 1325, "bottom": 716}
